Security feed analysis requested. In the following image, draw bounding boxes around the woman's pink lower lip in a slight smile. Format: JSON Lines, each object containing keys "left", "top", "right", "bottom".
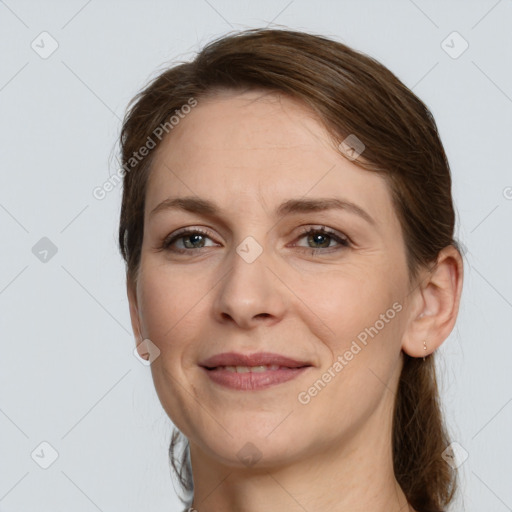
{"left": 203, "top": 366, "right": 311, "bottom": 391}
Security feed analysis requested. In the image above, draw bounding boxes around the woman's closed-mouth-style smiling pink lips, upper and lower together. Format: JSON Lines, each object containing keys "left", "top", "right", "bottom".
{"left": 200, "top": 352, "right": 312, "bottom": 391}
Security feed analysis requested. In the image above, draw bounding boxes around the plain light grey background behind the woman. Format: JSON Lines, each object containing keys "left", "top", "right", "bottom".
{"left": 0, "top": 0, "right": 512, "bottom": 512}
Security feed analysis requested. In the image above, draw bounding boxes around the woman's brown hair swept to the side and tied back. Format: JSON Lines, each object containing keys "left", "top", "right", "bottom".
{"left": 119, "top": 29, "right": 461, "bottom": 512}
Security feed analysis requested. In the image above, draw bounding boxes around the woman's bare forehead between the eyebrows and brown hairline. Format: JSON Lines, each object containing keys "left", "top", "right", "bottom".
{"left": 146, "top": 91, "right": 394, "bottom": 229}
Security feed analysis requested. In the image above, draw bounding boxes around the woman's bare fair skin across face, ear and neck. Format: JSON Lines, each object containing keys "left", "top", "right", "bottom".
{"left": 128, "top": 91, "right": 462, "bottom": 512}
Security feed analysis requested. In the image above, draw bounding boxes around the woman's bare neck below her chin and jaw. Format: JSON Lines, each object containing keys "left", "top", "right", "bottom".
{"left": 186, "top": 393, "right": 412, "bottom": 512}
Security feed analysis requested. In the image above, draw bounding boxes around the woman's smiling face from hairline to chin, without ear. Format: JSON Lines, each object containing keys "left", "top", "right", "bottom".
{"left": 129, "top": 91, "right": 416, "bottom": 467}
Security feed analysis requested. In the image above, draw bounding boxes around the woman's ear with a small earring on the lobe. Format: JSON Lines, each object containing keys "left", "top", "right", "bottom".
{"left": 402, "top": 245, "right": 463, "bottom": 357}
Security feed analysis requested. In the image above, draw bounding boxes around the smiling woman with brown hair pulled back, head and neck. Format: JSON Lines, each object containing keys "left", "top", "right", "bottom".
{"left": 119, "top": 29, "right": 463, "bottom": 512}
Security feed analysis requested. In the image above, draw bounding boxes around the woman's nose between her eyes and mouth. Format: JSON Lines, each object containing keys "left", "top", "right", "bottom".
{"left": 214, "top": 244, "right": 289, "bottom": 329}
